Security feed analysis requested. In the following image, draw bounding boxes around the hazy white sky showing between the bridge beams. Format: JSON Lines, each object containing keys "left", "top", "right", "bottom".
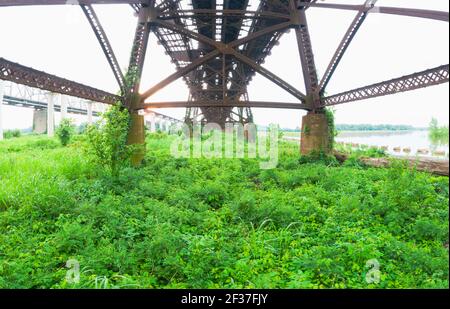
{"left": 0, "top": 0, "right": 449, "bottom": 128}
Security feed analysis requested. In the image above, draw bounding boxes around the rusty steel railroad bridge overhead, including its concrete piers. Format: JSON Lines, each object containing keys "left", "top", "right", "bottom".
{"left": 0, "top": 0, "right": 449, "bottom": 161}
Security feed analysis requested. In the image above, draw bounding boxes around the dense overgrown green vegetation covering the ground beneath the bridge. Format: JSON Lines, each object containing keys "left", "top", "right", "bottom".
{"left": 0, "top": 135, "right": 449, "bottom": 288}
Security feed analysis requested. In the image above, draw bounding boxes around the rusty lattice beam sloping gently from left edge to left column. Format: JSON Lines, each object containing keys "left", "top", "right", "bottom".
{"left": 0, "top": 58, "right": 121, "bottom": 104}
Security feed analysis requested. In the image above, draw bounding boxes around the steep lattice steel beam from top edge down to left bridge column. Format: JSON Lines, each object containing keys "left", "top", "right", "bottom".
{"left": 80, "top": 5, "right": 125, "bottom": 94}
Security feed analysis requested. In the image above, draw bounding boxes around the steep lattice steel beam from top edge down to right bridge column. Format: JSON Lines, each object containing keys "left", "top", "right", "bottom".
{"left": 319, "top": 0, "right": 377, "bottom": 94}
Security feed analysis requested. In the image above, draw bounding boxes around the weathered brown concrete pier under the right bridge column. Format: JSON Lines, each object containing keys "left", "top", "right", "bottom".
{"left": 300, "top": 113, "right": 332, "bottom": 155}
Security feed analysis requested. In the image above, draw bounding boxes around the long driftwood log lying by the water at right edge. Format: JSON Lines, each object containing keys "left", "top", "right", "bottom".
{"left": 334, "top": 152, "right": 449, "bottom": 176}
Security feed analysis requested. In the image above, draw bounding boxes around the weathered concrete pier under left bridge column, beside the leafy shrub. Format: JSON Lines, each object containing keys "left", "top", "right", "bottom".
{"left": 127, "top": 95, "right": 145, "bottom": 167}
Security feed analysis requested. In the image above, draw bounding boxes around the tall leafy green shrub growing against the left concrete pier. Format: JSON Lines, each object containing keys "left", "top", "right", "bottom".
{"left": 85, "top": 104, "right": 133, "bottom": 177}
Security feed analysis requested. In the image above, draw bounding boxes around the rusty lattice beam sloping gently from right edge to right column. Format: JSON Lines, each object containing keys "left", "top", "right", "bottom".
{"left": 322, "top": 64, "right": 449, "bottom": 107}
